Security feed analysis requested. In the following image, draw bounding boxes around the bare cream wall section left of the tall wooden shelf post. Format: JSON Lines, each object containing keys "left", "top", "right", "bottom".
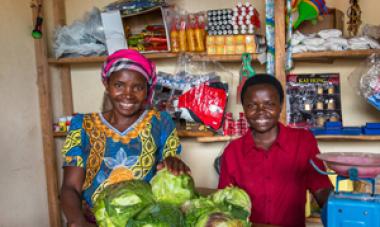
{"left": 0, "top": 0, "right": 49, "bottom": 227}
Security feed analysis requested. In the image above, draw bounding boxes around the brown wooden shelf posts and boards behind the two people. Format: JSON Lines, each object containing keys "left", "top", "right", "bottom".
{"left": 33, "top": 0, "right": 380, "bottom": 227}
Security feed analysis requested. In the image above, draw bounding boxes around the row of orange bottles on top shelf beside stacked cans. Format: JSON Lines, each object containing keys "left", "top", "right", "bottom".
{"left": 170, "top": 14, "right": 205, "bottom": 52}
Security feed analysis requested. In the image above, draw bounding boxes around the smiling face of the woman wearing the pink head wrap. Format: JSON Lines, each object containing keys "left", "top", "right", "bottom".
{"left": 104, "top": 69, "right": 148, "bottom": 119}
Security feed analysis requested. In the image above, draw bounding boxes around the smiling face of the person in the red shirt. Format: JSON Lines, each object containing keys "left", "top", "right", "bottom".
{"left": 243, "top": 84, "right": 282, "bottom": 133}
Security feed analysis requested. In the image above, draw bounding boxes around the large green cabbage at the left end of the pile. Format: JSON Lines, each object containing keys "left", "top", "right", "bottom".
{"left": 93, "top": 180, "right": 154, "bottom": 227}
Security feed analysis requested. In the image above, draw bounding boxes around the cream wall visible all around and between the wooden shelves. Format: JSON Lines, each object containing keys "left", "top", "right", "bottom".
{"left": 0, "top": 0, "right": 380, "bottom": 227}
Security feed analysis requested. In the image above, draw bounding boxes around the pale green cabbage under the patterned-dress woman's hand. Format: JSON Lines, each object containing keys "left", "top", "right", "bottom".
{"left": 150, "top": 168, "right": 197, "bottom": 206}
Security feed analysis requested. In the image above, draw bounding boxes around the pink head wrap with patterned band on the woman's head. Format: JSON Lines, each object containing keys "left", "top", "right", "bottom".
{"left": 102, "top": 49, "right": 157, "bottom": 103}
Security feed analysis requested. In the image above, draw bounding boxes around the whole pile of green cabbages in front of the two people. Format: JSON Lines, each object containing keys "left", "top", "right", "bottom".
{"left": 93, "top": 169, "right": 251, "bottom": 227}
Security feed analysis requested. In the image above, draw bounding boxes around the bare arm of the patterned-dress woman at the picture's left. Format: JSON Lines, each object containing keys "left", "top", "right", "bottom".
{"left": 61, "top": 166, "right": 95, "bottom": 227}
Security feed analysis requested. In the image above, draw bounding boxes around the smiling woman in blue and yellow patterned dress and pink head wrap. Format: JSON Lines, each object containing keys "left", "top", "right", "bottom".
{"left": 61, "top": 50, "right": 190, "bottom": 227}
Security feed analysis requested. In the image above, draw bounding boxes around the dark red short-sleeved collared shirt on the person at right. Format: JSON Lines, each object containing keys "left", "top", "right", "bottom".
{"left": 218, "top": 123, "right": 332, "bottom": 227}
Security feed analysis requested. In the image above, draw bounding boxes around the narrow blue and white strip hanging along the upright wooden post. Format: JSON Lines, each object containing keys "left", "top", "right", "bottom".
{"left": 265, "top": 0, "right": 275, "bottom": 75}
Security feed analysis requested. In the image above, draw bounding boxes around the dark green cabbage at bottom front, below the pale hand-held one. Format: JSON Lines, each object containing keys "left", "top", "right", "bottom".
{"left": 127, "top": 203, "right": 184, "bottom": 227}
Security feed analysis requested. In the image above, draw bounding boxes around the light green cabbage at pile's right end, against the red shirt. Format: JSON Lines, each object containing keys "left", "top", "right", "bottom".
{"left": 210, "top": 186, "right": 252, "bottom": 217}
